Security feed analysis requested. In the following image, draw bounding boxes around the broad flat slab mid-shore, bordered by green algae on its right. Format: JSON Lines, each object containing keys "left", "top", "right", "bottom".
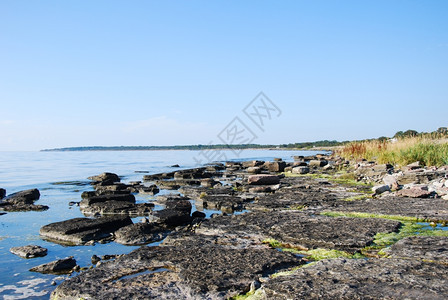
{"left": 196, "top": 210, "right": 401, "bottom": 253}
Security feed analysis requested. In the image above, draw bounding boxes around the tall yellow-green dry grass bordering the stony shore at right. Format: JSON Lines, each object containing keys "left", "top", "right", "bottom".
{"left": 337, "top": 135, "right": 448, "bottom": 166}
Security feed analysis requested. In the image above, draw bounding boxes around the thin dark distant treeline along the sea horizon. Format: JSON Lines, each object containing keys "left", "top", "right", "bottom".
{"left": 42, "top": 141, "right": 341, "bottom": 151}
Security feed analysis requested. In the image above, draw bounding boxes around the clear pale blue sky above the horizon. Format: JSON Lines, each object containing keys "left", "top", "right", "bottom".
{"left": 0, "top": 0, "right": 448, "bottom": 150}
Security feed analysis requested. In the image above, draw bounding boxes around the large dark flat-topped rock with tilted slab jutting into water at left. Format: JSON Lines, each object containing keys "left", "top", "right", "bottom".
{"left": 39, "top": 216, "right": 132, "bottom": 244}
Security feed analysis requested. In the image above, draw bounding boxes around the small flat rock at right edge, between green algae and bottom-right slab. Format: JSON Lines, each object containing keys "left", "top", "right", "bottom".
{"left": 387, "top": 236, "right": 448, "bottom": 264}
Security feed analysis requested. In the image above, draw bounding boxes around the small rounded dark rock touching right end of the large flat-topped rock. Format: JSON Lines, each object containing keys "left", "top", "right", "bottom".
{"left": 114, "top": 223, "right": 168, "bottom": 245}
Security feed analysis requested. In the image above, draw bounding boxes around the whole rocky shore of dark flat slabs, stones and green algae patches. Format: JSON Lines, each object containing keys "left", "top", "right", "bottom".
{"left": 0, "top": 155, "right": 448, "bottom": 299}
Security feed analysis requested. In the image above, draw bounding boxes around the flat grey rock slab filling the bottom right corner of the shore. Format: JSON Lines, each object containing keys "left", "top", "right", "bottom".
{"left": 257, "top": 259, "right": 448, "bottom": 299}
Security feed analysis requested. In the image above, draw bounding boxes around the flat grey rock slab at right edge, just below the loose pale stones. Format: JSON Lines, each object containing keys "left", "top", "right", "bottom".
{"left": 330, "top": 197, "right": 448, "bottom": 222}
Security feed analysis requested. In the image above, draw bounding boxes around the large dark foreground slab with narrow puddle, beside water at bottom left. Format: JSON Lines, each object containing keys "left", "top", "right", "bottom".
{"left": 52, "top": 237, "right": 303, "bottom": 299}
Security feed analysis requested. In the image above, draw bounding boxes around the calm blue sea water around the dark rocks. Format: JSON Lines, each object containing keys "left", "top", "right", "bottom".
{"left": 0, "top": 150, "right": 326, "bottom": 299}
